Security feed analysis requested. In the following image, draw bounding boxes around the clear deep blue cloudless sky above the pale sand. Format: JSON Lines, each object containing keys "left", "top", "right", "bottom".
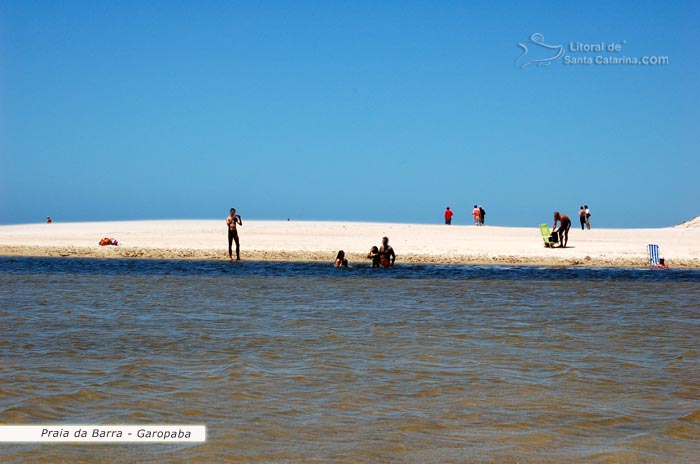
{"left": 0, "top": 0, "right": 700, "bottom": 227}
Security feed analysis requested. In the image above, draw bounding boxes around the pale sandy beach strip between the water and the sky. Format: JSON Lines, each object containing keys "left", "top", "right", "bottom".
{"left": 0, "top": 220, "right": 700, "bottom": 268}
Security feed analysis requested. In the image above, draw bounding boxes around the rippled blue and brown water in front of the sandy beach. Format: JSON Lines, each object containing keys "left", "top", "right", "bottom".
{"left": 0, "top": 258, "right": 700, "bottom": 463}
